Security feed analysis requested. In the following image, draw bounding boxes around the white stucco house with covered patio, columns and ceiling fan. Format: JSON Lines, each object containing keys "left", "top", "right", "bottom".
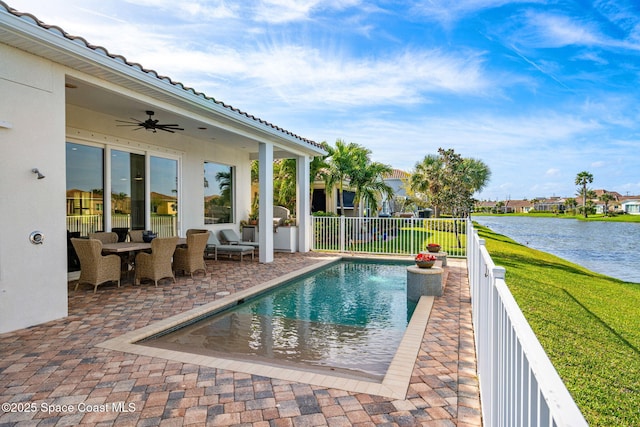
{"left": 0, "top": 1, "right": 325, "bottom": 333}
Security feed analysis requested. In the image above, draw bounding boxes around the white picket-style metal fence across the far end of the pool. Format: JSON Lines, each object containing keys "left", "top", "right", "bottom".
{"left": 311, "top": 216, "right": 467, "bottom": 257}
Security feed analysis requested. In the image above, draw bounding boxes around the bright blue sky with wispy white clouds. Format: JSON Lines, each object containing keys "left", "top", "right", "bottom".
{"left": 8, "top": 0, "right": 640, "bottom": 200}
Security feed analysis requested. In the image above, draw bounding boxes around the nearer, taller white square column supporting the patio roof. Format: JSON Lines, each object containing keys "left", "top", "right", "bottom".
{"left": 258, "top": 143, "right": 273, "bottom": 263}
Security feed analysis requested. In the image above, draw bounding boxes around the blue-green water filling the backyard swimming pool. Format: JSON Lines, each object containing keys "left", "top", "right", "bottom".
{"left": 141, "top": 261, "right": 416, "bottom": 379}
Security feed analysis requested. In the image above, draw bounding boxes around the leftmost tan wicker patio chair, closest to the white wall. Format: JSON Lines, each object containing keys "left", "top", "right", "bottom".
{"left": 71, "top": 238, "right": 120, "bottom": 294}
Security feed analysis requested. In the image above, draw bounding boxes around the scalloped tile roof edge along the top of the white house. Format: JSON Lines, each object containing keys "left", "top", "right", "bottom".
{"left": 0, "top": 0, "right": 322, "bottom": 148}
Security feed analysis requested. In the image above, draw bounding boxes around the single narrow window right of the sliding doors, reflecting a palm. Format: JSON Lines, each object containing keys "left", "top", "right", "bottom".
{"left": 204, "top": 162, "right": 234, "bottom": 224}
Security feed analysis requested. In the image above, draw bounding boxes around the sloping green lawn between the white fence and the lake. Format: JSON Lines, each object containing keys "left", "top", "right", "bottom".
{"left": 475, "top": 224, "right": 640, "bottom": 426}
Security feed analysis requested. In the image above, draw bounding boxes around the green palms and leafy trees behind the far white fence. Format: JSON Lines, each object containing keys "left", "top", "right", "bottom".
{"left": 262, "top": 139, "right": 491, "bottom": 217}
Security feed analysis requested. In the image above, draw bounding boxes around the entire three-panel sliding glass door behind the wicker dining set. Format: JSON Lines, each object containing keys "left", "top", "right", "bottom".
{"left": 67, "top": 142, "right": 179, "bottom": 237}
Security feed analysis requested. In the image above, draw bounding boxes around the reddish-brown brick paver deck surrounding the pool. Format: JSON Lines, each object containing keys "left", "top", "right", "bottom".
{"left": 0, "top": 253, "right": 482, "bottom": 427}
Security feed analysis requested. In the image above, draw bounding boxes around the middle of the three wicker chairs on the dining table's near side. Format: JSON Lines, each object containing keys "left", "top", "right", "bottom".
{"left": 135, "top": 237, "right": 178, "bottom": 286}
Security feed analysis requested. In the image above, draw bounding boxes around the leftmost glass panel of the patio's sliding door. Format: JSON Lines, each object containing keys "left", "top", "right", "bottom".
{"left": 66, "top": 142, "right": 104, "bottom": 237}
